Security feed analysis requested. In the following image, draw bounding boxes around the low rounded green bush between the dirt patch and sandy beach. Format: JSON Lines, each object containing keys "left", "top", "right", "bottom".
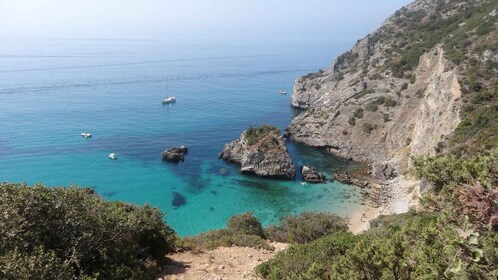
{"left": 266, "top": 212, "right": 348, "bottom": 243}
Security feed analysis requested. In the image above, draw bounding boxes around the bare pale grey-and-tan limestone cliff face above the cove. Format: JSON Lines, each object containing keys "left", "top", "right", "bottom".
{"left": 288, "top": 46, "right": 461, "bottom": 173}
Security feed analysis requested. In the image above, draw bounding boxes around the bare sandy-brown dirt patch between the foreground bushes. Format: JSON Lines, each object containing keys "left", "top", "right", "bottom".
{"left": 162, "top": 243, "right": 287, "bottom": 280}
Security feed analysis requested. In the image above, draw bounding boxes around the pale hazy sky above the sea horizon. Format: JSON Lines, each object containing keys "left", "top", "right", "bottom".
{"left": 0, "top": 0, "right": 411, "bottom": 42}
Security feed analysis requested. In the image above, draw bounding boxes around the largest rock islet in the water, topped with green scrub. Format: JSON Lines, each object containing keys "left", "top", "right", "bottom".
{"left": 219, "top": 126, "right": 295, "bottom": 179}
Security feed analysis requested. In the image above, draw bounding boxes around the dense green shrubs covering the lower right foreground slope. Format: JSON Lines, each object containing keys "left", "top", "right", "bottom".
{"left": 257, "top": 151, "right": 498, "bottom": 279}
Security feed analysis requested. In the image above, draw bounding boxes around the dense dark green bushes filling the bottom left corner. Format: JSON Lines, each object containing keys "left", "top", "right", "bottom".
{"left": 0, "top": 183, "right": 175, "bottom": 280}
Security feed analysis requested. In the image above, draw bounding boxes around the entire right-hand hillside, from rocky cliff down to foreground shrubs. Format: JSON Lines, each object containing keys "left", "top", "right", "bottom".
{"left": 257, "top": 0, "right": 498, "bottom": 279}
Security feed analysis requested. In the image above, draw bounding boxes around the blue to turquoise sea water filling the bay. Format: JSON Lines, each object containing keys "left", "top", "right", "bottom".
{"left": 0, "top": 39, "right": 360, "bottom": 236}
